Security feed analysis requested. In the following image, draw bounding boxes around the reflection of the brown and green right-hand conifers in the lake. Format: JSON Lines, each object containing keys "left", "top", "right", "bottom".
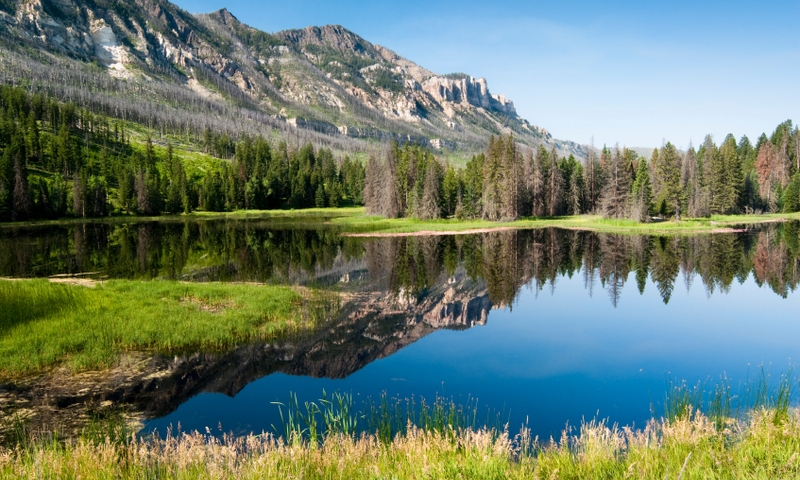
{"left": 365, "top": 223, "right": 800, "bottom": 306}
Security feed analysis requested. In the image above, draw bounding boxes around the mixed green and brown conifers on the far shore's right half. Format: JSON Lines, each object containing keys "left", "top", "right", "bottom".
{"left": 364, "top": 124, "right": 800, "bottom": 222}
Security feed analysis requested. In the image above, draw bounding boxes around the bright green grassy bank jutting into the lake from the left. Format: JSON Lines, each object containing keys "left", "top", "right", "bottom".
{"left": 0, "top": 280, "right": 335, "bottom": 376}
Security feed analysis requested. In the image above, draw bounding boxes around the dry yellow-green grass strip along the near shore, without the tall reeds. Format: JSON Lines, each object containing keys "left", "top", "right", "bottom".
{"left": 0, "top": 410, "right": 800, "bottom": 480}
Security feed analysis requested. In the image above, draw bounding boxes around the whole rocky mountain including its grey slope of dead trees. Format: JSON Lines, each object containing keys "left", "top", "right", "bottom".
{"left": 0, "top": 0, "right": 583, "bottom": 156}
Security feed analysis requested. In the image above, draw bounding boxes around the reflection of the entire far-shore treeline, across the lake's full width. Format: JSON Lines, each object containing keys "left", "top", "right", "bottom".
{"left": 0, "top": 221, "right": 800, "bottom": 306}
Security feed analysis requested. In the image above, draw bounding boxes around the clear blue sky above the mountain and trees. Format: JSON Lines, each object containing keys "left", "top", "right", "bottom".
{"left": 177, "top": 0, "right": 800, "bottom": 147}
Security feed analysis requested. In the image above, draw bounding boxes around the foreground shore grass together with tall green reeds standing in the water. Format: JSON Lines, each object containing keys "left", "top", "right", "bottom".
{"left": 0, "top": 369, "right": 800, "bottom": 480}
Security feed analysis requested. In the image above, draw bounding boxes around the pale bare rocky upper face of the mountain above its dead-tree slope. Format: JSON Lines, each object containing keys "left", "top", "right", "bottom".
{"left": 0, "top": 0, "right": 582, "bottom": 155}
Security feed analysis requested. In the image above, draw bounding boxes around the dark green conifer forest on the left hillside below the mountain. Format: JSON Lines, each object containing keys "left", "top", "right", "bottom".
{"left": 0, "top": 86, "right": 365, "bottom": 221}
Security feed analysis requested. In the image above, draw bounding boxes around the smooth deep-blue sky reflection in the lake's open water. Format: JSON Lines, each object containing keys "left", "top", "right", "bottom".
{"left": 147, "top": 229, "right": 800, "bottom": 438}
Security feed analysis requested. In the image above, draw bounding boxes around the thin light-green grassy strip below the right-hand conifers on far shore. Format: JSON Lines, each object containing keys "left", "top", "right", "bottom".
{"left": 330, "top": 213, "right": 800, "bottom": 235}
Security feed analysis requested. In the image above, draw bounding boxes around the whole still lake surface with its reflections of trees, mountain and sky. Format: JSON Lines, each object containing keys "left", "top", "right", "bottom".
{"left": 0, "top": 219, "right": 800, "bottom": 438}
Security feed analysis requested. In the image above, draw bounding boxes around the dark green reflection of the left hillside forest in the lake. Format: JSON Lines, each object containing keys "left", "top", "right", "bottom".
{"left": 0, "top": 220, "right": 363, "bottom": 283}
